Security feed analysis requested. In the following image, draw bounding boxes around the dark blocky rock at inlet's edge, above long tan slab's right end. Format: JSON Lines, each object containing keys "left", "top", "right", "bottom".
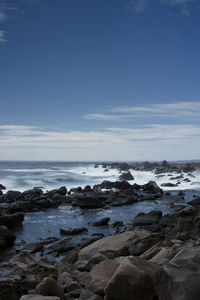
{"left": 132, "top": 210, "right": 162, "bottom": 226}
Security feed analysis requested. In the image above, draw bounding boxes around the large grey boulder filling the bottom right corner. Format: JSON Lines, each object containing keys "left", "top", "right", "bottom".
{"left": 155, "top": 247, "right": 200, "bottom": 300}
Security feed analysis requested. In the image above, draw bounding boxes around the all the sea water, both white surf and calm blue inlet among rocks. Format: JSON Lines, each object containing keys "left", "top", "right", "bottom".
{"left": 0, "top": 161, "right": 200, "bottom": 252}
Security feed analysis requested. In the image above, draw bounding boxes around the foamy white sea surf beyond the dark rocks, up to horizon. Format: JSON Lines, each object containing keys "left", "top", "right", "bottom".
{"left": 0, "top": 162, "right": 200, "bottom": 191}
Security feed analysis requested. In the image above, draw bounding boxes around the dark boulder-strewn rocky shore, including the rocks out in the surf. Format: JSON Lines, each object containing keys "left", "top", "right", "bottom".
{"left": 0, "top": 162, "right": 200, "bottom": 300}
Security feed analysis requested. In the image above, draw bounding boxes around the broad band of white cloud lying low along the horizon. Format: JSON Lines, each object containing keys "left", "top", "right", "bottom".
{"left": 0, "top": 124, "right": 200, "bottom": 161}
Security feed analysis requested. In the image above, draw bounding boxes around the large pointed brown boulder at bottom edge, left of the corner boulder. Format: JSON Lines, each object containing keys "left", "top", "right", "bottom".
{"left": 104, "top": 257, "right": 159, "bottom": 300}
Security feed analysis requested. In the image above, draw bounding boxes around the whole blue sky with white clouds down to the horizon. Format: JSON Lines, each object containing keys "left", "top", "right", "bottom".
{"left": 0, "top": 0, "right": 200, "bottom": 161}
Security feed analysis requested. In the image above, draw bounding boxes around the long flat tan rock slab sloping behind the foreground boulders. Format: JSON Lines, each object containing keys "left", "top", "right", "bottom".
{"left": 77, "top": 230, "right": 148, "bottom": 264}
